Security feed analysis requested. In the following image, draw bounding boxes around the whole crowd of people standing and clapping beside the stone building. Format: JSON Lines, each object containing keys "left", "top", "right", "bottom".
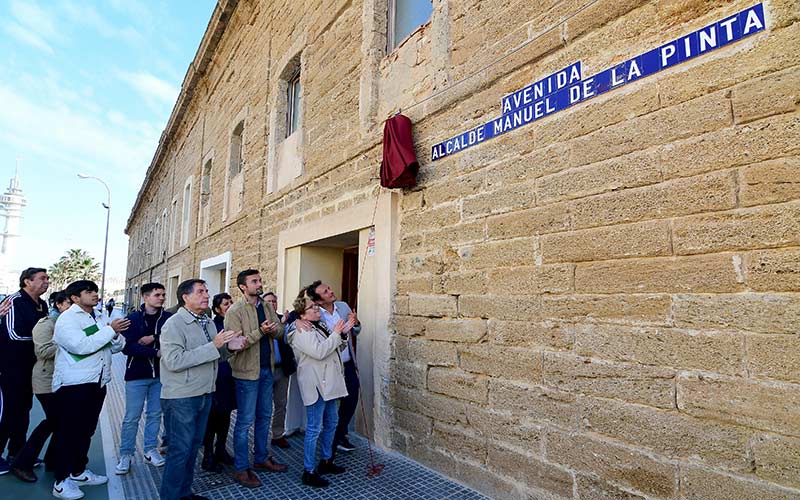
{"left": 0, "top": 268, "right": 360, "bottom": 500}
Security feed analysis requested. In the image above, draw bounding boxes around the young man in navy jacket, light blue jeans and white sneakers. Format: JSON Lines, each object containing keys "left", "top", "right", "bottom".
{"left": 115, "top": 283, "right": 171, "bottom": 474}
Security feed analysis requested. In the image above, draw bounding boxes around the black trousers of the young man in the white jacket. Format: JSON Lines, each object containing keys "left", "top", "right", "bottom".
{"left": 53, "top": 382, "right": 106, "bottom": 481}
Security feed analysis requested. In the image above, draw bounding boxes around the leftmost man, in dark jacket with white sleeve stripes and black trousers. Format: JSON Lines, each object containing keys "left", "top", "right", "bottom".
{"left": 0, "top": 267, "right": 50, "bottom": 474}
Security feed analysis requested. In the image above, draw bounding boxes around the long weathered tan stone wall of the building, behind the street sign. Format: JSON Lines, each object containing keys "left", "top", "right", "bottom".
{"left": 128, "top": 0, "right": 800, "bottom": 499}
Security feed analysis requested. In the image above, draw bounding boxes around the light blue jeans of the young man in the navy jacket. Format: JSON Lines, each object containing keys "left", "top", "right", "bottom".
{"left": 119, "top": 378, "right": 161, "bottom": 455}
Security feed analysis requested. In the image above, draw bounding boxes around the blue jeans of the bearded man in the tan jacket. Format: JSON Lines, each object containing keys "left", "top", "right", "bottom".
{"left": 233, "top": 367, "right": 273, "bottom": 471}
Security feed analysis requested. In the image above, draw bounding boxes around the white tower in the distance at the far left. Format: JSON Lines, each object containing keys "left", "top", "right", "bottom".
{"left": 0, "top": 162, "right": 26, "bottom": 294}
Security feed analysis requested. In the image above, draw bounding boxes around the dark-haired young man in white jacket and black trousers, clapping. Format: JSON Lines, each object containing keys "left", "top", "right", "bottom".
{"left": 53, "top": 280, "right": 130, "bottom": 499}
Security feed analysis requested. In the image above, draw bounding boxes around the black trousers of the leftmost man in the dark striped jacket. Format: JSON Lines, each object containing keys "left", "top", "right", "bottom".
{"left": 0, "top": 339, "right": 36, "bottom": 456}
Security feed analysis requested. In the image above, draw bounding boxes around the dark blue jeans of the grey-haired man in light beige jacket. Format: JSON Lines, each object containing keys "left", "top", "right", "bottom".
{"left": 161, "top": 394, "right": 213, "bottom": 500}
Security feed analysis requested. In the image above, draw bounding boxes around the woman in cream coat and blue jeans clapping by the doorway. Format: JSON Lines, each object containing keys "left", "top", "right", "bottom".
{"left": 287, "top": 297, "right": 353, "bottom": 488}
